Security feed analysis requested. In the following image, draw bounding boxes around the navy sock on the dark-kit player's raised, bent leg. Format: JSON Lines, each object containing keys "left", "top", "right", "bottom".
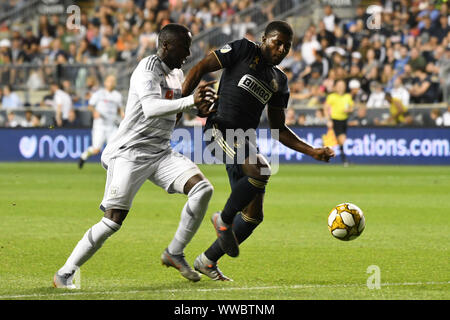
{"left": 221, "top": 176, "right": 267, "bottom": 224}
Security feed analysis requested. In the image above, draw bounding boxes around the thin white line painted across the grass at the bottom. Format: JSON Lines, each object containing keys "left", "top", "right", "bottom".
{"left": 0, "top": 281, "right": 450, "bottom": 300}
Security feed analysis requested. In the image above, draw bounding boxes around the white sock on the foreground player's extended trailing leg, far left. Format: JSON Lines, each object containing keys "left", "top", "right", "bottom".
{"left": 58, "top": 217, "right": 120, "bottom": 274}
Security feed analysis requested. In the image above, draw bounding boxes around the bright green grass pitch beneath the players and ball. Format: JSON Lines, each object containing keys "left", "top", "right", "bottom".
{"left": 0, "top": 163, "right": 450, "bottom": 300}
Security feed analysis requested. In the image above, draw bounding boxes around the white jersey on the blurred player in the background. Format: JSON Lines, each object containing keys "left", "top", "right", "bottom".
{"left": 89, "top": 89, "right": 122, "bottom": 126}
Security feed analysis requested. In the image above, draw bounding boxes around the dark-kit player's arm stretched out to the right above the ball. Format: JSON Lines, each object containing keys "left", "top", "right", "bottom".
{"left": 268, "top": 107, "right": 334, "bottom": 162}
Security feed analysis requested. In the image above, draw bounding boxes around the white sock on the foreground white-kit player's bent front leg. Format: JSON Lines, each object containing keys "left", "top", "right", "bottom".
{"left": 168, "top": 180, "right": 214, "bottom": 254}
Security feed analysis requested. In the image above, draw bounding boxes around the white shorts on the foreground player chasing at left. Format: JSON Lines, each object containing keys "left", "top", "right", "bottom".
{"left": 100, "top": 149, "right": 201, "bottom": 211}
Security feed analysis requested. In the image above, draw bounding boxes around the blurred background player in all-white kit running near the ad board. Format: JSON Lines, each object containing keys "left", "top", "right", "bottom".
{"left": 78, "top": 75, "right": 124, "bottom": 169}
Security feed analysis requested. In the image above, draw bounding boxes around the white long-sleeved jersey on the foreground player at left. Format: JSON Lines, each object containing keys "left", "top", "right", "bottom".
{"left": 102, "top": 55, "right": 194, "bottom": 163}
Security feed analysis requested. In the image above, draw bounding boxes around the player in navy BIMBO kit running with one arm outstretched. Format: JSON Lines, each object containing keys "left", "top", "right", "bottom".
{"left": 182, "top": 21, "right": 334, "bottom": 281}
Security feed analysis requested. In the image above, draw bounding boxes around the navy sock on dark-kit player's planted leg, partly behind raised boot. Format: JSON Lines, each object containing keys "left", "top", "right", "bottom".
{"left": 205, "top": 213, "right": 261, "bottom": 261}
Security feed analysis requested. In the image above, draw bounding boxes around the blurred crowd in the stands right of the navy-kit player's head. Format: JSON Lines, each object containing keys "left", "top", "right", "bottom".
{"left": 280, "top": 0, "right": 450, "bottom": 125}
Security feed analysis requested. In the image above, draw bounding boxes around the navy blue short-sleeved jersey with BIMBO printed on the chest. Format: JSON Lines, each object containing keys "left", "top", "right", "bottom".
{"left": 208, "top": 38, "right": 289, "bottom": 130}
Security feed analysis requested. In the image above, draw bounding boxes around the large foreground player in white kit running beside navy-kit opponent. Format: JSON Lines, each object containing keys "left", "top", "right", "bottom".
{"left": 53, "top": 24, "right": 217, "bottom": 289}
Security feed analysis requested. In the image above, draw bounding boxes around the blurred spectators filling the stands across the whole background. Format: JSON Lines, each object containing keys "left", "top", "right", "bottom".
{"left": 0, "top": 0, "right": 450, "bottom": 127}
